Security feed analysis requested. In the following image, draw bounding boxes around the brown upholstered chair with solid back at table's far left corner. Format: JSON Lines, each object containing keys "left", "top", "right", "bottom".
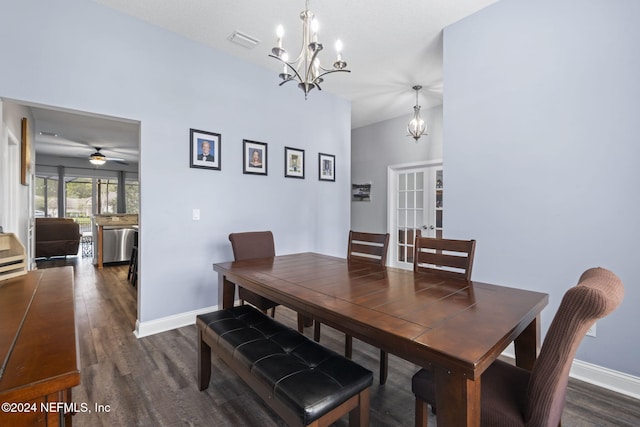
{"left": 229, "top": 231, "right": 279, "bottom": 317}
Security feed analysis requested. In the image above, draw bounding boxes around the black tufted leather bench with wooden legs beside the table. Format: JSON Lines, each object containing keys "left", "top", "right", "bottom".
{"left": 196, "top": 305, "right": 373, "bottom": 427}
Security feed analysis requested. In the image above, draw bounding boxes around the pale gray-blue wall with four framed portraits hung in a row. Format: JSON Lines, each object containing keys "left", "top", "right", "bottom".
{"left": 0, "top": 0, "right": 351, "bottom": 328}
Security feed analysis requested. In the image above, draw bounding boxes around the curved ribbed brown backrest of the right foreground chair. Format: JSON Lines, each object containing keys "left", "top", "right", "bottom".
{"left": 525, "top": 268, "right": 624, "bottom": 427}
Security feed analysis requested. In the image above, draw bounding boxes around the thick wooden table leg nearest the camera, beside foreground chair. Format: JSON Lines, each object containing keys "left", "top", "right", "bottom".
{"left": 434, "top": 367, "right": 481, "bottom": 427}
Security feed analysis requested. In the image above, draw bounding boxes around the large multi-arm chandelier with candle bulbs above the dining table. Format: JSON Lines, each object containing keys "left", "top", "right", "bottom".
{"left": 269, "top": 0, "right": 351, "bottom": 99}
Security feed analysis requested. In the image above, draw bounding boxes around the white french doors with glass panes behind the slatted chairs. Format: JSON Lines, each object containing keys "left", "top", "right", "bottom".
{"left": 387, "top": 161, "right": 443, "bottom": 270}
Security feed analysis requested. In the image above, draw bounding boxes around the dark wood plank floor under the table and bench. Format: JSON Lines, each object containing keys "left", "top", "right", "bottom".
{"left": 38, "top": 257, "right": 640, "bottom": 427}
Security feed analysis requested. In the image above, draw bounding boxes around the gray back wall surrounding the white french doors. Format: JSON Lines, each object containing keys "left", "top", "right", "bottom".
{"left": 351, "top": 104, "right": 446, "bottom": 233}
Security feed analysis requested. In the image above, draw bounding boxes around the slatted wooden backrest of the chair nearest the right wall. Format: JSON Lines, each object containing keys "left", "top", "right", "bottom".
{"left": 413, "top": 232, "right": 476, "bottom": 280}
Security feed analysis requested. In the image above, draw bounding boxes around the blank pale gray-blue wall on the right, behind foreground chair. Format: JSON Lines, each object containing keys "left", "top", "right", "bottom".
{"left": 443, "top": 0, "right": 640, "bottom": 376}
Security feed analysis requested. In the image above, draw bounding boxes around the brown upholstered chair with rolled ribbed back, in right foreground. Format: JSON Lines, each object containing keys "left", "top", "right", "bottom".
{"left": 411, "top": 268, "right": 624, "bottom": 427}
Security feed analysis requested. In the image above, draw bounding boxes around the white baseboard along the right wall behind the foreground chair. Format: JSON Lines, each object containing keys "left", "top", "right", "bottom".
{"left": 502, "top": 344, "right": 640, "bottom": 399}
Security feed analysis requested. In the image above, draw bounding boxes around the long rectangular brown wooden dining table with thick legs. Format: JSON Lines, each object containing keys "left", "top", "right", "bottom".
{"left": 213, "top": 253, "right": 548, "bottom": 427}
